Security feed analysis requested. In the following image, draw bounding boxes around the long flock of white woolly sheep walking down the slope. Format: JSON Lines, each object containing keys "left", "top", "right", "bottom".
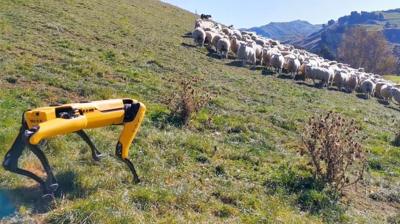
{"left": 192, "top": 18, "right": 400, "bottom": 104}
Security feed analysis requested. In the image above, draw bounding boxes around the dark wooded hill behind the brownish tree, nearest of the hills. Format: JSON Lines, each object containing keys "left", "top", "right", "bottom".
{"left": 287, "top": 9, "right": 400, "bottom": 59}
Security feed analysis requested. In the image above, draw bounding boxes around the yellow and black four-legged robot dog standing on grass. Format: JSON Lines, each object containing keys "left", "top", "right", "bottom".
{"left": 3, "top": 99, "right": 146, "bottom": 195}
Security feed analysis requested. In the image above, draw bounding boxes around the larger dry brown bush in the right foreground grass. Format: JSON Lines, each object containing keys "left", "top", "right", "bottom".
{"left": 301, "top": 112, "right": 366, "bottom": 191}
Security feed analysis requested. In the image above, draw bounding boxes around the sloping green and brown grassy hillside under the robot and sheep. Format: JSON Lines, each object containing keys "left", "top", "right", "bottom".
{"left": 0, "top": 0, "right": 400, "bottom": 223}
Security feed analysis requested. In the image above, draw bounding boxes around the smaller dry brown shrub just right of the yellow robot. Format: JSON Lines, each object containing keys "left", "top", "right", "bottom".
{"left": 164, "top": 77, "right": 213, "bottom": 126}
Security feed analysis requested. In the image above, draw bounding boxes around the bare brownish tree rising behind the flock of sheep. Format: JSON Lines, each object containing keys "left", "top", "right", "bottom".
{"left": 337, "top": 27, "right": 397, "bottom": 75}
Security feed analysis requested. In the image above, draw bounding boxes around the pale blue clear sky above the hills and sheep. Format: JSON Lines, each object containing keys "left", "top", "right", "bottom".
{"left": 163, "top": 0, "right": 400, "bottom": 28}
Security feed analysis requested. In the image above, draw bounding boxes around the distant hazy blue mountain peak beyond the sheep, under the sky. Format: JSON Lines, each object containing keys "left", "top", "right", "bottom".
{"left": 246, "top": 20, "right": 322, "bottom": 41}
